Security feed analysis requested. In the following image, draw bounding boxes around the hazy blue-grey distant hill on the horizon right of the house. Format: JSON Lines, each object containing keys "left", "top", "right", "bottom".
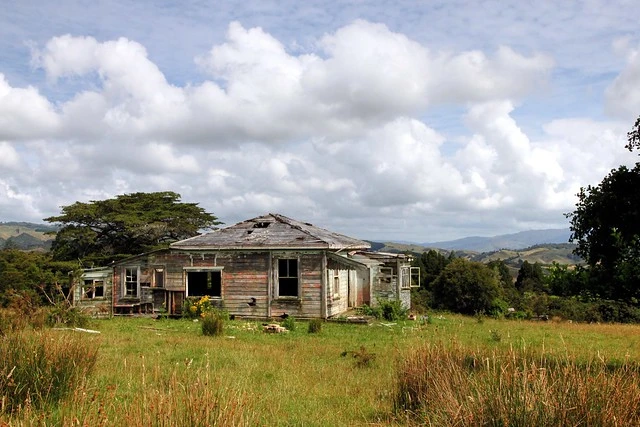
{"left": 420, "top": 228, "right": 571, "bottom": 252}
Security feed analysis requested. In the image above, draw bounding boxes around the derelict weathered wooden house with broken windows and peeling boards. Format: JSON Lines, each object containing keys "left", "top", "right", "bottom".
{"left": 78, "top": 214, "right": 416, "bottom": 318}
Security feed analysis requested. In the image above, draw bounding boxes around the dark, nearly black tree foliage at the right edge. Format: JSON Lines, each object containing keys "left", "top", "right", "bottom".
{"left": 567, "top": 162, "right": 640, "bottom": 302}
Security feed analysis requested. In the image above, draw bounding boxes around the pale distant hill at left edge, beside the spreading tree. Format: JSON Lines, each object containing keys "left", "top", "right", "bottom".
{"left": 0, "top": 222, "right": 57, "bottom": 250}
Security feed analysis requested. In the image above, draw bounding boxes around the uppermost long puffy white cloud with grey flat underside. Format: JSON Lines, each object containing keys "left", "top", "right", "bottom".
{"left": 18, "top": 21, "right": 551, "bottom": 146}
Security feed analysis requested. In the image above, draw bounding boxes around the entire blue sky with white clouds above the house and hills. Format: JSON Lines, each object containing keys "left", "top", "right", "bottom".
{"left": 0, "top": 0, "right": 640, "bottom": 242}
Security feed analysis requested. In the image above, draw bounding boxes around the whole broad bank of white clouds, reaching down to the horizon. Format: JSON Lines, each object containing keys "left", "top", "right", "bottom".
{"left": 0, "top": 20, "right": 635, "bottom": 244}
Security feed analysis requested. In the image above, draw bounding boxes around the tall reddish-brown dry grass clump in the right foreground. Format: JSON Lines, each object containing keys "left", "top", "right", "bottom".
{"left": 394, "top": 344, "right": 640, "bottom": 426}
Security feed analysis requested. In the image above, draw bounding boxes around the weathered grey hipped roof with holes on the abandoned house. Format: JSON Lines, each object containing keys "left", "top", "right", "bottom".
{"left": 170, "top": 213, "right": 371, "bottom": 250}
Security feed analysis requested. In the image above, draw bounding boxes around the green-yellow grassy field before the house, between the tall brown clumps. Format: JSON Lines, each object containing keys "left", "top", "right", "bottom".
{"left": 0, "top": 314, "right": 640, "bottom": 426}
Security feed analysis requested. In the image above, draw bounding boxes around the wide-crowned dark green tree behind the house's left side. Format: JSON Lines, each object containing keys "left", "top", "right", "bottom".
{"left": 45, "top": 191, "right": 221, "bottom": 263}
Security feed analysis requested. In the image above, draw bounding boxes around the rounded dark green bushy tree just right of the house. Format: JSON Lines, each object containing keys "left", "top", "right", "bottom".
{"left": 433, "top": 258, "right": 501, "bottom": 314}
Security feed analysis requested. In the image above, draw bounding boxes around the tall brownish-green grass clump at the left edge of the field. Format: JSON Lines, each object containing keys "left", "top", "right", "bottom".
{"left": 0, "top": 330, "right": 98, "bottom": 412}
